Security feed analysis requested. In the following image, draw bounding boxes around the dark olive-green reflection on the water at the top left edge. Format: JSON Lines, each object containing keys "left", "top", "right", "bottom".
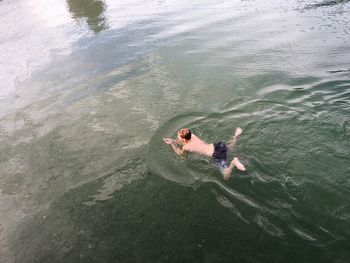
{"left": 67, "top": 0, "right": 108, "bottom": 33}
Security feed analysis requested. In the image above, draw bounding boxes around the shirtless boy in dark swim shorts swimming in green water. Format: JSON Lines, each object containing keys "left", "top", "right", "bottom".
{"left": 163, "top": 128, "right": 245, "bottom": 180}
